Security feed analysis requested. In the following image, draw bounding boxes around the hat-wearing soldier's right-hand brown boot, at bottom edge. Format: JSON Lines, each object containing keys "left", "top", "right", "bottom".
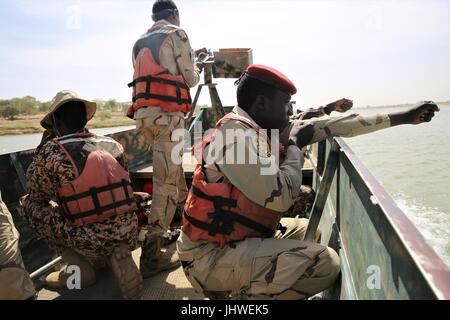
{"left": 110, "top": 243, "right": 142, "bottom": 300}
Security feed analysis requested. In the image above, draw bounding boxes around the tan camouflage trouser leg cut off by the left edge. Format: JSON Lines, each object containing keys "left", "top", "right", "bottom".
{"left": 0, "top": 200, "right": 35, "bottom": 300}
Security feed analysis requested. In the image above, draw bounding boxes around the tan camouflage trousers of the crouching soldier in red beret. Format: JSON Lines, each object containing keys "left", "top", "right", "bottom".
{"left": 179, "top": 218, "right": 340, "bottom": 300}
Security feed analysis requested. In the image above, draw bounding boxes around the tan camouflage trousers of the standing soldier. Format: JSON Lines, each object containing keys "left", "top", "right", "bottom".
{"left": 136, "top": 112, "right": 188, "bottom": 230}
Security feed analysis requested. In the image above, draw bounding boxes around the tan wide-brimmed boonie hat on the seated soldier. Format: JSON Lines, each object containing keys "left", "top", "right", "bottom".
{"left": 41, "top": 90, "right": 97, "bottom": 129}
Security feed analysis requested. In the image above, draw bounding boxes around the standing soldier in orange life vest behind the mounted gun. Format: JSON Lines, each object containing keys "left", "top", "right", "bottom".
{"left": 127, "top": 0, "right": 201, "bottom": 278}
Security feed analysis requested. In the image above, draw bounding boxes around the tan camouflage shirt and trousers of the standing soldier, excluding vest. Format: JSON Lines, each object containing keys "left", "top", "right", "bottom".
{"left": 133, "top": 20, "right": 200, "bottom": 229}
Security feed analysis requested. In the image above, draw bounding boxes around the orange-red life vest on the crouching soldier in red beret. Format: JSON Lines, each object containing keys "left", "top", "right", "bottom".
{"left": 182, "top": 113, "right": 284, "bottom": 246}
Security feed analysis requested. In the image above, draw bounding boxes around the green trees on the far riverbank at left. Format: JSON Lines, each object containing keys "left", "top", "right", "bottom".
{"left": 0, "top": 96, "right": 131, "bottom": 120}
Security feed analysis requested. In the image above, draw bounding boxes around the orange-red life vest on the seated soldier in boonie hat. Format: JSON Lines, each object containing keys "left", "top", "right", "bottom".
{"left": 54, "top": 133, "right": 137, "bottom": 227}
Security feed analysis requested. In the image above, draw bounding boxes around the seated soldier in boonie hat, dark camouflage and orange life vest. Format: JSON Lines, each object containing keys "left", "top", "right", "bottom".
{"left": 19, "top": 90, "right": 142, "bottom": 299}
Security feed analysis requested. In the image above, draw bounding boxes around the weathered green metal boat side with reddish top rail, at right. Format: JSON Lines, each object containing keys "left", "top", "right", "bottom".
{"left": 305, "top": 138, "right": 450, "bottom": 299}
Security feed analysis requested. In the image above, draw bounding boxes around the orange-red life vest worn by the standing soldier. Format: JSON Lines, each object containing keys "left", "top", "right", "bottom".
{"left": 127, "top": 25, "right": 192, "bottom": 118}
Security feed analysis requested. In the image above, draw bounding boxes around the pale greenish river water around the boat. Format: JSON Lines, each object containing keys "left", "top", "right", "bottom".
{"left": 0, "top": 105, "right": 450, "bottom": 265}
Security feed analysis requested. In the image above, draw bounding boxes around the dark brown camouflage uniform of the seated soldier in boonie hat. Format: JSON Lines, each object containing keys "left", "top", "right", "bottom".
{"left": 19, "top": 131, "right": 138, "bottom": 265}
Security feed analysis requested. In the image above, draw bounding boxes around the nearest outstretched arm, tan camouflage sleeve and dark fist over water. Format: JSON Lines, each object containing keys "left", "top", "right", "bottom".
{"left": 288, "top": 101, "right": 439, "bottom": 147}
